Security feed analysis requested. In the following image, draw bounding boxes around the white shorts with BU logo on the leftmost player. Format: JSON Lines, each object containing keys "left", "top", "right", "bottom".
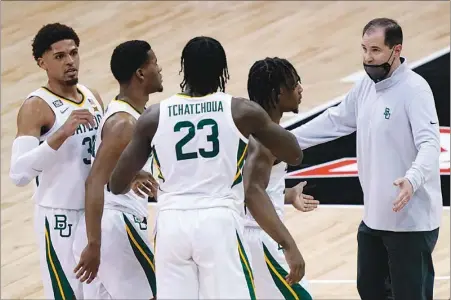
{"left": 34, "top": 205, "right": 83, "bottom": 299}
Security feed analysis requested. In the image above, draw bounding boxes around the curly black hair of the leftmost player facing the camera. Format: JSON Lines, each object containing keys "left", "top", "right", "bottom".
{"left": 32, "top": 23, "right": 80, "bottom": 61}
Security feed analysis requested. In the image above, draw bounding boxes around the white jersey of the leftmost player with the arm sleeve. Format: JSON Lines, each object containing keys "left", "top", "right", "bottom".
{"left": 27, "top": 84, "right": 103, "bottom": 209}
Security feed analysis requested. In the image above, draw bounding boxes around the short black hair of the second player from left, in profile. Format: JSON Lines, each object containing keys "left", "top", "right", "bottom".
{"left": 110, "top": 40, "right": 152, "bottom": 84}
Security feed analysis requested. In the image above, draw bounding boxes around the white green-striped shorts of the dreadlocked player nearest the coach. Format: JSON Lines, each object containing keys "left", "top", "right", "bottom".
{"left": 244, "top": 227, "right": 312, "bottom": 300}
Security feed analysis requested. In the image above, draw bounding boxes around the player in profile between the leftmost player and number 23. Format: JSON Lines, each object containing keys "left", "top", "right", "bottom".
{"left": 74, "top": 40, "right": 163, "bottom": 299}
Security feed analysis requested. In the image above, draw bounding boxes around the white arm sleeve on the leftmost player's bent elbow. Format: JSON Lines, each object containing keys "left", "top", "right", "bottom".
{"left": 9, "top": 136, "right": 56, "bottom": 186}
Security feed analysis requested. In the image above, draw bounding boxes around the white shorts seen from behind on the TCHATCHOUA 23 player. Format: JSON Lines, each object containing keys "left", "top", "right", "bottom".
{"left": 155, "top": 207, "right": 255, "bottom": 300}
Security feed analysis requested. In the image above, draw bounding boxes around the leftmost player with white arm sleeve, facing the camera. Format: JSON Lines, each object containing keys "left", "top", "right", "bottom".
{"left": 9, "top": 23, "right": 103, "bottom": 299}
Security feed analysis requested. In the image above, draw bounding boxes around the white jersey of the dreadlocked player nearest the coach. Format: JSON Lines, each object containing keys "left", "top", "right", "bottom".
{"left": 245, "top": 161, "right": 287, "bottom": 226}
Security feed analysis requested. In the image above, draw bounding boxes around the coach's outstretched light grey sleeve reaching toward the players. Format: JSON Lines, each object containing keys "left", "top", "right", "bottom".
{"left": 291, "top": 86, "right": 357, "bottom": 149}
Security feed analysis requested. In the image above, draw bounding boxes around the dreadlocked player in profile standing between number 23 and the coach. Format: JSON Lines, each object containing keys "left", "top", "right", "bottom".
{"left": 243, "top": 57, "right": 318, "bottom": 299}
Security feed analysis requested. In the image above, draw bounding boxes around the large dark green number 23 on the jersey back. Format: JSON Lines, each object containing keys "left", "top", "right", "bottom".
{"left": 174, "top": 119, "right": 219, "bottom": 160}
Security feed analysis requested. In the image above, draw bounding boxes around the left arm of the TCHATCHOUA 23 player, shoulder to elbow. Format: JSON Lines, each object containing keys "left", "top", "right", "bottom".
{"left": 110, "top": 103, "right": 160, "bottom": 195}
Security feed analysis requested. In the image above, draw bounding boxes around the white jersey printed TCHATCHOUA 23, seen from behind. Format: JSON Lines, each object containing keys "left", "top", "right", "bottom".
{"left": 152, "top": 92, "right": 248, "bottom": 214}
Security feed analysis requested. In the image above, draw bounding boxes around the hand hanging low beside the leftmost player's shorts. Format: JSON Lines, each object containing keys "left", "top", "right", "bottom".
{"left": 74, "top": 244, "right": 100, "bottom": 284}
